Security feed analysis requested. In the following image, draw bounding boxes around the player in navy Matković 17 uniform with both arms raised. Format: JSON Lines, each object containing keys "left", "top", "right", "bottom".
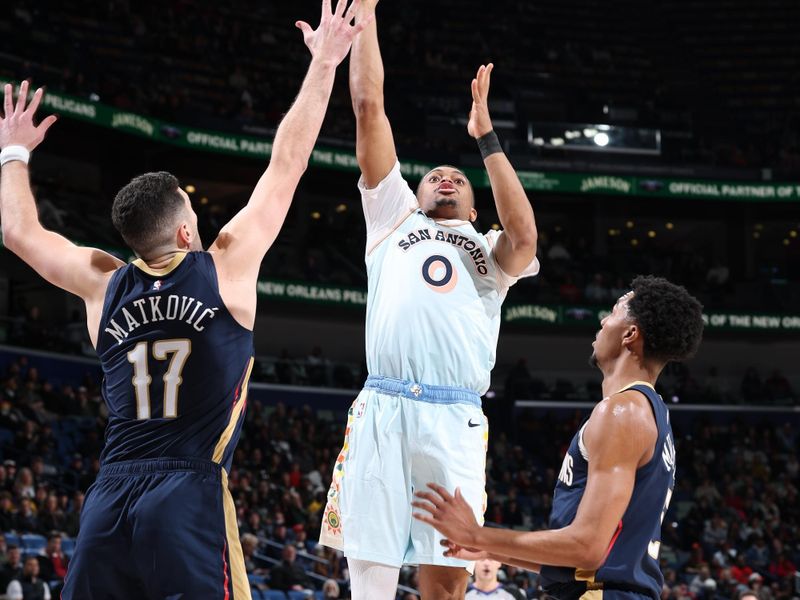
{"left": 0, "top": 0, "right": 365, "bottom": 600}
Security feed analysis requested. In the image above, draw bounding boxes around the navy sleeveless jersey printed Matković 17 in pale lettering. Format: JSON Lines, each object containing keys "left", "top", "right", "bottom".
{"left": 97, "top": 252, "right": 253, "bottom": 472}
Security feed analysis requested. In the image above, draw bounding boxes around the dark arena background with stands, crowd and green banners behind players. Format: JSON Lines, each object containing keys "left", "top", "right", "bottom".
{"left": 0, "top": 0, "right": 800, "bottom": 600}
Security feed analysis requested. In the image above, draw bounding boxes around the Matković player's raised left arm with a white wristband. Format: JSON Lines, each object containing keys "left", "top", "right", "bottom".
{"left": 0, "top": 81, "right": 123, "bottom": 304}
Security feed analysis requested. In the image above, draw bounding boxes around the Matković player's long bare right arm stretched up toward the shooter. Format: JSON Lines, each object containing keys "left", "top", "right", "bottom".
{"left": 209, "top": 0, "right": 366, "bottom": 288}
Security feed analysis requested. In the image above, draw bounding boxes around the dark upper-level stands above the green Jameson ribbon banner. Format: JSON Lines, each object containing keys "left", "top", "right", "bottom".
{"left": 0, "top": 0, "right": 800, "bottom": 168}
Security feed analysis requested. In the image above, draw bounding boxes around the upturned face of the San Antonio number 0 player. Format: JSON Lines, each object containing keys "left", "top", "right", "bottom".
{"left": 417, "top": 165, "right": 478, "bottom": 221}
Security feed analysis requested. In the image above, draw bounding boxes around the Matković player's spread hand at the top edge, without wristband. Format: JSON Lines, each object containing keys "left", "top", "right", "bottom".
{"left": 295, "top": 0, "right": 374, "bottom": 65}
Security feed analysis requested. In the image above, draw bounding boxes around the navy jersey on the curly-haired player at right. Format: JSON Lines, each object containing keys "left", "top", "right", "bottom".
{"left": 541, "top": 382, "right": 675, "bottom": 600}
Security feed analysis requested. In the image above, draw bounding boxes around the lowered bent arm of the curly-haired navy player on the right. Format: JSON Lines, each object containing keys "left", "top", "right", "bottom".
{"left": 413, "top": 392, "right": 657, "bottom": 571}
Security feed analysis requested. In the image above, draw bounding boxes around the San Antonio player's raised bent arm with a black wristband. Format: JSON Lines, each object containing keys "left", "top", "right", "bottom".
{"left": 467, "top": 63, "right": 538, "bottom": 277}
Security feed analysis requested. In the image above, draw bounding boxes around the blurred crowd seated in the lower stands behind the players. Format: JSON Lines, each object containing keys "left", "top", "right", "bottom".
{"left": 0, "top": 356, "right": 800, "bottom": 600}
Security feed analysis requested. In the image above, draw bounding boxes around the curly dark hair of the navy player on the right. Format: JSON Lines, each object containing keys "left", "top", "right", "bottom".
{"left": 628, "top": 275, "right": 703, "bottom": 363}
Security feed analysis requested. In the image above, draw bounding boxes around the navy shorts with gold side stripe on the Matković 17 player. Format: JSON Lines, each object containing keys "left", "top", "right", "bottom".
{"left": 61, "top": 459, "right": 250, "bottom": 600}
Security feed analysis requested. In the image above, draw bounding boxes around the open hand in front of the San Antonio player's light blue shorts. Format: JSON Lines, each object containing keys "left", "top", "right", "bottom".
{"left": 411, "top": 483, "right": 480, "bottom": 548}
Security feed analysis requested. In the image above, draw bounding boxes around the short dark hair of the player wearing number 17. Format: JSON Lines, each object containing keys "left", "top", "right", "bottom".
{"left": 111, "top": 171, "right": 184, "bottom": 256}
